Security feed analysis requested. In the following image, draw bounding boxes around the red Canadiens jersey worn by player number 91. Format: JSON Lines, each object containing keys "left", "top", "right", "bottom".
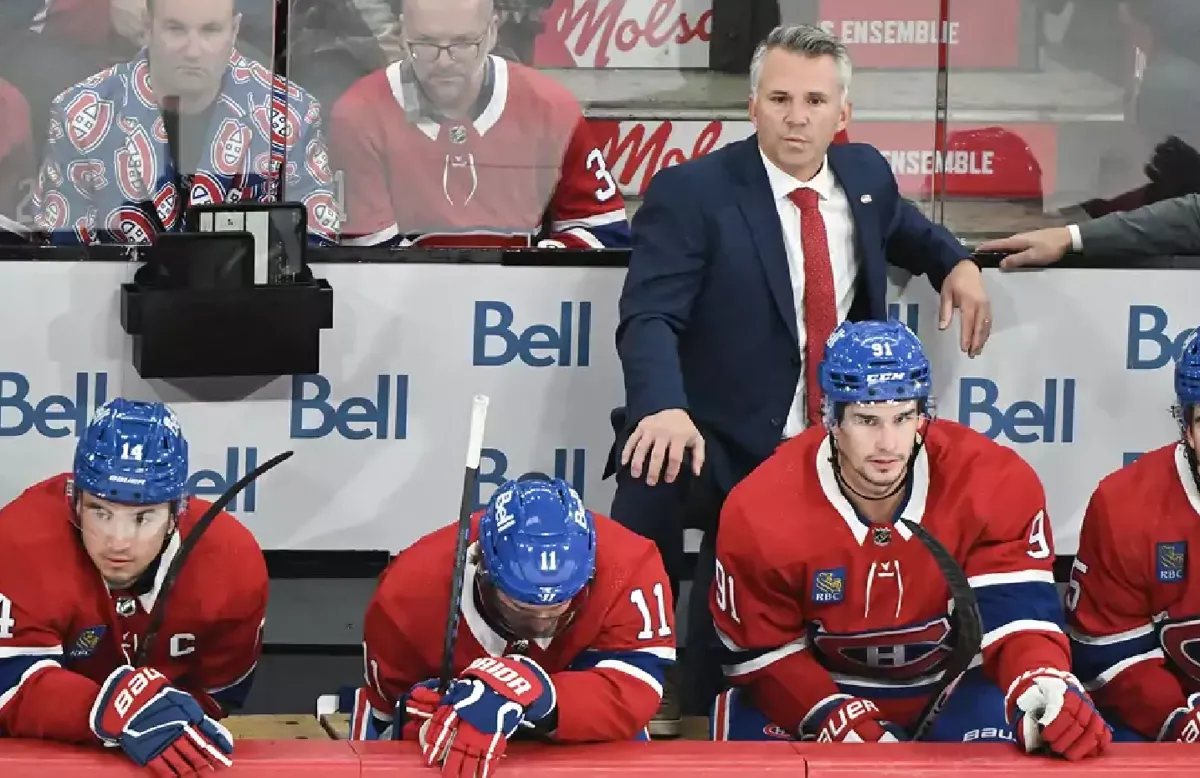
{"left": 710, "top": 420, "right": 1068, "bottom": 734}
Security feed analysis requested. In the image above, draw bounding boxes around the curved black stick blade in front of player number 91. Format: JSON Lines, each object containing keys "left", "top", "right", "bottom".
{"left": 900, "top": 519, "right": 983, "bottom": 741}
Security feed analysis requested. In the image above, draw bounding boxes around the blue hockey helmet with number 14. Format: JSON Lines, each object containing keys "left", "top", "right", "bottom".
{"left": 73, "top": 397, "right": 187, "bottom": 505}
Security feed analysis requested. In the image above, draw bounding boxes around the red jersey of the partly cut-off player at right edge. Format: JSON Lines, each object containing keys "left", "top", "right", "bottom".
{"left": 1067, "top": 444, "right": 1200, "bottom": 740}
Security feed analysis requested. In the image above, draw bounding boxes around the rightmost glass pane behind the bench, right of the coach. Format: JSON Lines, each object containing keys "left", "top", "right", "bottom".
{"left": 938, "top": 0, "right": 1200, "bottom": 234}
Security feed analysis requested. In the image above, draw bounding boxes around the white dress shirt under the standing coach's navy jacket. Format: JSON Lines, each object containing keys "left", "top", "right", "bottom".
{"left": 758, "top": 149, "right": 858, "bottom": 438}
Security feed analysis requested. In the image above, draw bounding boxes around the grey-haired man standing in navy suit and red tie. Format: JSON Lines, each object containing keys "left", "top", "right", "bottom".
{"left": 610, "top": 25, "right": 991, "bottom": 723}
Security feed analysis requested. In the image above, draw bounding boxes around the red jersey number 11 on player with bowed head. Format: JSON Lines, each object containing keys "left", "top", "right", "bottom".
{"left": 352, "top": 514, "right": 676, "bottom": 742}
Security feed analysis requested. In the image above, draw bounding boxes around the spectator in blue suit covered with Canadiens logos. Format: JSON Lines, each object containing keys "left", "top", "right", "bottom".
{"left": 34, "top": 0, "right": 338, "bottom": 244}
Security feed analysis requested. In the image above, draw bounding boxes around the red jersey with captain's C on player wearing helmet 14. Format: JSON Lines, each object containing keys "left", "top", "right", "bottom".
{"left": 0, "top": 475, "right": 268, "bottom": 742}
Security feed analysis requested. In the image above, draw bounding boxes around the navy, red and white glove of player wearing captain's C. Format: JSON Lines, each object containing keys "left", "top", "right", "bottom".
{"left": 91, "top": 665, "right": 233, "bottom": 777}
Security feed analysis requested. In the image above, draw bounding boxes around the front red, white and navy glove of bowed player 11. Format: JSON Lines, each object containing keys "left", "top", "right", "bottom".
{"left": 420, "top": 656, "right": 557, "bottom": 778}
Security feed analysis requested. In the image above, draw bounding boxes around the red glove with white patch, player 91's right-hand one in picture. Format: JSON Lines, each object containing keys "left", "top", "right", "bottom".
{"left": 1004, "top": 668, "right": 1112, "bottom": 761}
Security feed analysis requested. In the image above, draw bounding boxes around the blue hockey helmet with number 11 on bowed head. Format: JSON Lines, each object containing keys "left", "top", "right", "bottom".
{"left": 479, "top": 478, "right": 596, "bottom": 606}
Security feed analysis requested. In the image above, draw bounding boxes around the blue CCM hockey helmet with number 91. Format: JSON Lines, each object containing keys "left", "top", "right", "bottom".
{"left": 818, "top": 321, "right": 930, "bottom": 403}
